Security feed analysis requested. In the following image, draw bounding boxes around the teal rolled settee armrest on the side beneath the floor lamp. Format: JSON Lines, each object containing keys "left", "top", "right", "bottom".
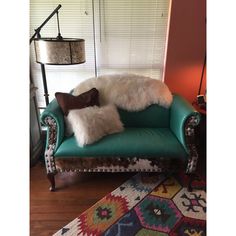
{"left": 41, "top": 99, "right": 65, "bottom": 154}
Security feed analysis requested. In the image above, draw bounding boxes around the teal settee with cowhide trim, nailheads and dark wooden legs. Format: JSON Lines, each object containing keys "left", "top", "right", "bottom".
{"left": 41, "top": 95, "right": 200, "bottom": 191}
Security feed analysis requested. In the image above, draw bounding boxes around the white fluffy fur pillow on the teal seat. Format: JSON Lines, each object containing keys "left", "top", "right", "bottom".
{"left": 67, "top": 105, "right": 124, "bottom": 147}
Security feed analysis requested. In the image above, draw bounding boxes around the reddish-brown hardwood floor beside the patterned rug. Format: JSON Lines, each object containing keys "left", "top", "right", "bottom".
{"left": 30, "top": 162, "right": 135, "bottom": 236}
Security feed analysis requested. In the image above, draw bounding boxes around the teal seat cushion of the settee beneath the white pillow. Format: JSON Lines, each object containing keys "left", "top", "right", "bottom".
{"left": 55, "top": 128, "right": 187, "bottom": 161}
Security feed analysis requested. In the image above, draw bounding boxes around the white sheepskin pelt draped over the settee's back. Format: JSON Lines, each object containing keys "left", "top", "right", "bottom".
{"left": 73, "top": 74, "right": 173, "bottom": 111}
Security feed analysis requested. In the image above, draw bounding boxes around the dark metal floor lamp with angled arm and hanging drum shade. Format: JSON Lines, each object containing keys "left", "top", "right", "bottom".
{"left": 30, "top": 4, "right": 85, "bottom": 106}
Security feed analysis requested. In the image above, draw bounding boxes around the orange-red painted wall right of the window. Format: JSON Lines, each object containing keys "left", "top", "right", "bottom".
{"left": 164, "top": 0, "right": 206, "bottom": 103}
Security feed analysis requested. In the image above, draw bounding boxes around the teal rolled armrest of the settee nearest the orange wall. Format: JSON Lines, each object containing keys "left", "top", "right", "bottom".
{"left": 170, "top": 95, "right": 200, "bottom": 153}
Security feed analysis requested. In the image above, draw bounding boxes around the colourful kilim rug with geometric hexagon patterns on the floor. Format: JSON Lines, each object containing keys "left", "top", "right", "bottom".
{"left": 54, "top": 173, "right": 206, "bottom": 236}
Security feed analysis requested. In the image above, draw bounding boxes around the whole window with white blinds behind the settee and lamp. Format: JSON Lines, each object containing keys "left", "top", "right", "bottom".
{"left": 30, "top": 0, "right": 170, "bottom": 107}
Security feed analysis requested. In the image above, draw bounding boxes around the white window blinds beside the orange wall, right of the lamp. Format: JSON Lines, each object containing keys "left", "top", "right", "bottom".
{"left": 97, "top": 0, "right": 170, "bottom": 79}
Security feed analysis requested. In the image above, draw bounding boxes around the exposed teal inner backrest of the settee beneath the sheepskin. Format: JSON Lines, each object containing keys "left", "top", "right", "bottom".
{"left": 118, "top": 104, "right": 170, "bottom": 128}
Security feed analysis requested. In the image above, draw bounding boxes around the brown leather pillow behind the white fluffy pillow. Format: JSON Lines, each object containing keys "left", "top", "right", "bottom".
{"left": 55, "top": 88, "right": 99, "bottom": 116}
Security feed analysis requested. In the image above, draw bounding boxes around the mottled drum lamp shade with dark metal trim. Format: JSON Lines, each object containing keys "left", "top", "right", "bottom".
{"left": 34, "top": 38, "right": 85, "bottom": 65}
